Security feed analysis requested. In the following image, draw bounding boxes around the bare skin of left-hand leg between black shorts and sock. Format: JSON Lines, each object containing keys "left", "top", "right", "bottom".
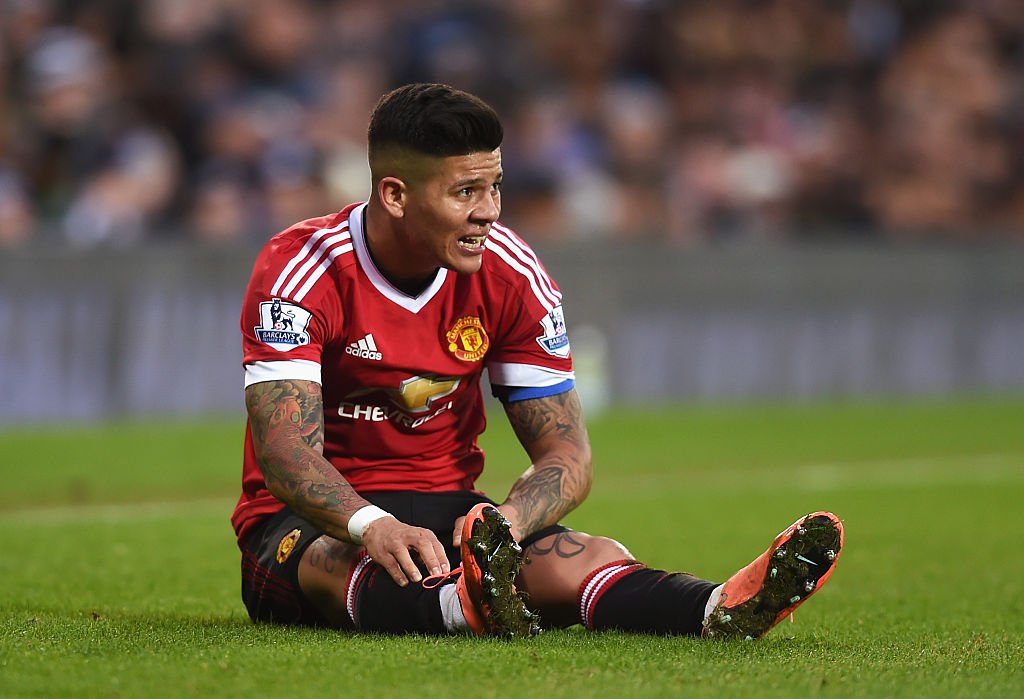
{"left": 299, "top": 534, "right": 359, "bottom": 628}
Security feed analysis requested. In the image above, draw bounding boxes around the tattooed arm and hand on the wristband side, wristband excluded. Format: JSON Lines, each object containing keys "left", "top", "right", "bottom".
{"left": 246, "top": 380, "right": 449, "bottom": 584}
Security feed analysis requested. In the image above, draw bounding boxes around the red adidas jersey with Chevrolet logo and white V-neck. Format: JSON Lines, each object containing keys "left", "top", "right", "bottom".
{"left": 231, "top": 204, "right": 574, "bottom": 538}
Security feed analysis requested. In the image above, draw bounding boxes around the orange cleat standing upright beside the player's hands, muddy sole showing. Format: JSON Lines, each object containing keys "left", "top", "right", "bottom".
{"left": 455, "top": 503, "right": 540, "bottom": 639}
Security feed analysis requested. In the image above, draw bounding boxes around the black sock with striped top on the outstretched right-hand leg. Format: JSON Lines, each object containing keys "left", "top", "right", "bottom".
{"left": 580, "top": 561, "right": 718, "bottom": 636}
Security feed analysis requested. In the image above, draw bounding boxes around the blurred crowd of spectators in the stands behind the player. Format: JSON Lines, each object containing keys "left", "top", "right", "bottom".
{"left": 0, "top": 0, "right": 1024, "bottom": 249}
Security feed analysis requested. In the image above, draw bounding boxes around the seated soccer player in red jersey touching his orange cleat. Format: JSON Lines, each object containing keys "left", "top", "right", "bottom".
{"left": 232, "top": 84, "right": 843, "bottom": 638}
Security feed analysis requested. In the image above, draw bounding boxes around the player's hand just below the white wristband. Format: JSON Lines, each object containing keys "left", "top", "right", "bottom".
{"left": 362, "top": 517, "right": 452, "bottom": 587}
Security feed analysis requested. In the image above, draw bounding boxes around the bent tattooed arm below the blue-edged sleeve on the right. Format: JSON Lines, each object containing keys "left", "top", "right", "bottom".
{"left": 501, "top": 389, "right": 593, "bottom": 538}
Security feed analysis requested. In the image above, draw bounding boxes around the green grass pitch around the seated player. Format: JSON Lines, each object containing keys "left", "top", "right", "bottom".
{"left": 0, "top": 399, "right": 1024, "bottom": 698}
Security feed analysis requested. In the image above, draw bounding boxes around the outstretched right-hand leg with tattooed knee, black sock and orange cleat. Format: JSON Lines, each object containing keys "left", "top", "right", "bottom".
{"left": 520, "top": 513, "right": 844, "bottom": 639}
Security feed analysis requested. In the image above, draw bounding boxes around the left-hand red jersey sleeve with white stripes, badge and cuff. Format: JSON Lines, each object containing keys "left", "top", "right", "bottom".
{"left": 241, "top": 221, "right": 340, "bottom": 388}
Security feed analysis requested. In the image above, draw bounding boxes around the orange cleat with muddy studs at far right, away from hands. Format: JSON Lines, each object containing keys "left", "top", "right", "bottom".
{"left": 701, "top": 512, "right": 844, "bottom": 641}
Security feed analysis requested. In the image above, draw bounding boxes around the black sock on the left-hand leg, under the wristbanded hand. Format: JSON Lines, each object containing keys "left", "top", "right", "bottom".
{"left": 353, "top": 563, "right": 445, "bottom": 634}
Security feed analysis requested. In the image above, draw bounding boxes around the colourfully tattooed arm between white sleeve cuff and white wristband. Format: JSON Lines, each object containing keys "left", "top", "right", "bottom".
{"left": 246, "top": 381, "right": 367, "bottom": 533}
